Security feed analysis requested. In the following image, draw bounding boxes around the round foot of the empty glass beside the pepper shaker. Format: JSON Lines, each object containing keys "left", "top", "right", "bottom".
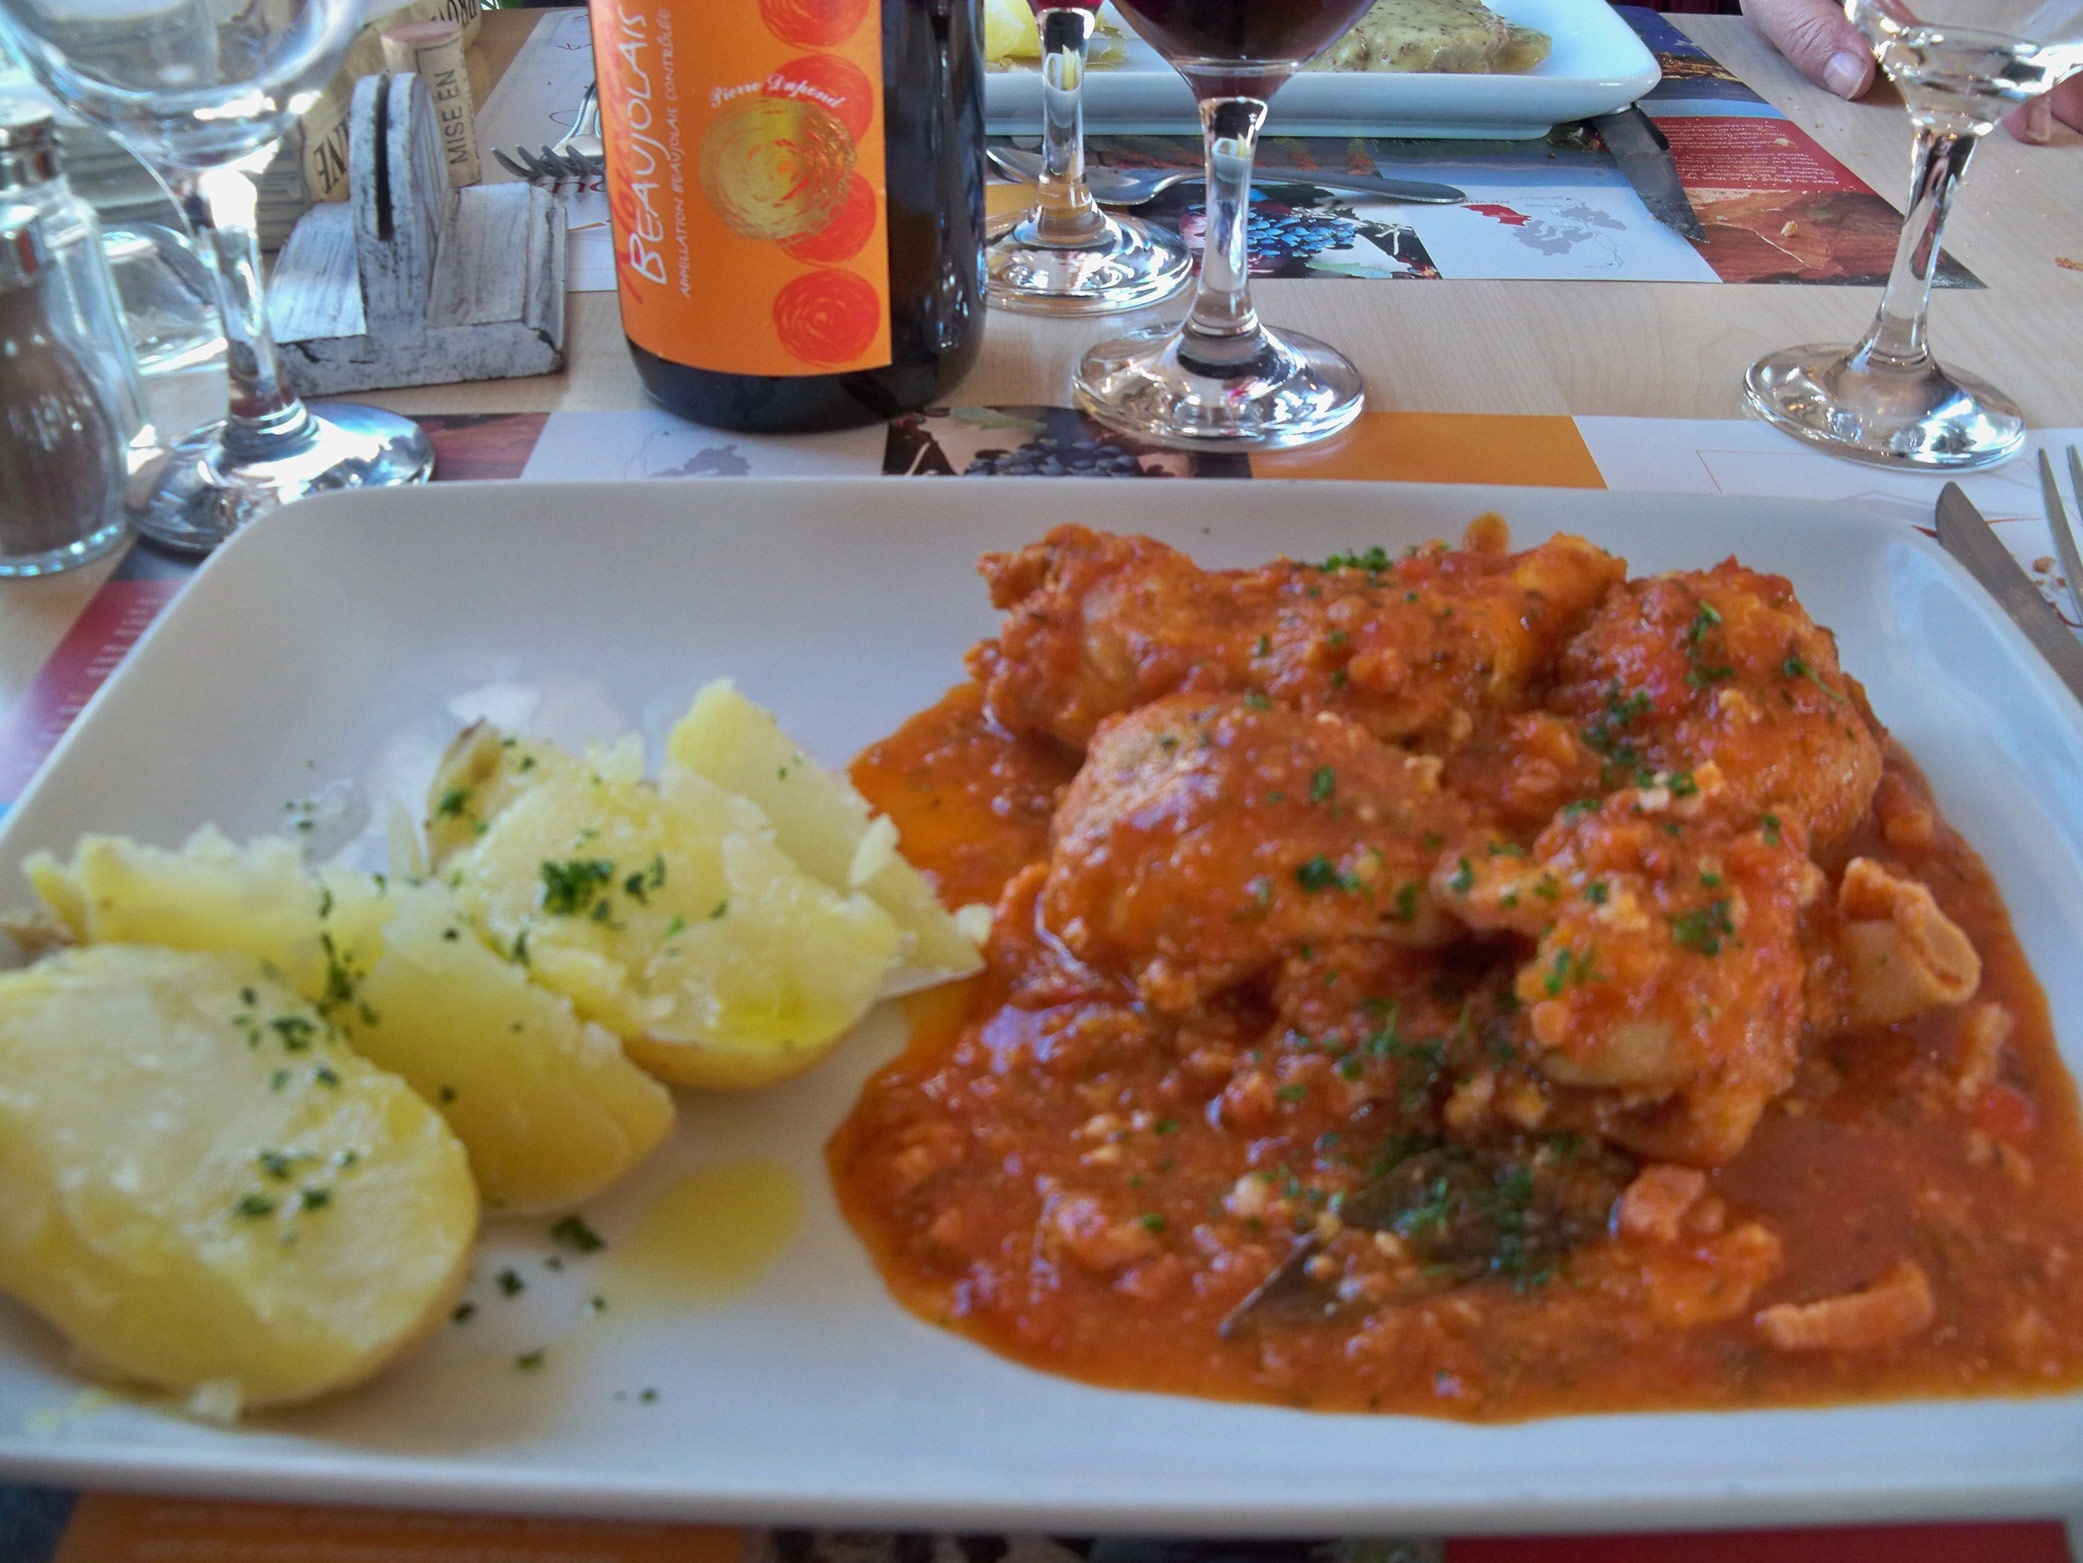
{"left": 131, "top": 402, "right": 433, "bottom": 554}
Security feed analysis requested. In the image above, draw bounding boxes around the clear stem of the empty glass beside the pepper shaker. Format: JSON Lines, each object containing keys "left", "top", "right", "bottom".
{"left": 167, "top": 167, "right": 310, "bottom": 465}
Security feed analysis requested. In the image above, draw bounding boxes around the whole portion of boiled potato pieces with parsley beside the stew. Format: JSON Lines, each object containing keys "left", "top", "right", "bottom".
{"left": 0, "top": 684, "right": 983, "bottom": 1415}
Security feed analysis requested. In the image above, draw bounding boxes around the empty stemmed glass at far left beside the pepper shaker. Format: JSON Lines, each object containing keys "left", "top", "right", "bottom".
{"left": 0, "top": 0, "right": 433, "bottom": 552}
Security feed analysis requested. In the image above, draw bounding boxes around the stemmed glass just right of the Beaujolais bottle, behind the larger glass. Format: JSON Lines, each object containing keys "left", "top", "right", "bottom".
{"left": 983, "top": 0, "right": 1194, "bottom": 315}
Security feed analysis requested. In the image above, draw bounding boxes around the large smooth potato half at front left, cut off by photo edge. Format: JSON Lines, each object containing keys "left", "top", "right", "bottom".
{"left": 0, "top": 944, "right": 477, "bottom": 1405}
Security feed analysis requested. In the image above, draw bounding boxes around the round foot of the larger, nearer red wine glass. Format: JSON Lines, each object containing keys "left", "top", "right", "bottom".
{"left": 1071, "top": 325, "right": 1366, "bottom": 450}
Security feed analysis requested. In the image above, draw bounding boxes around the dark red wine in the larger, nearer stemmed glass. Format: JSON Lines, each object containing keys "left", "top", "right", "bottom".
{"left": 1119, "top": 0, "right": 1373, "bottom": 98}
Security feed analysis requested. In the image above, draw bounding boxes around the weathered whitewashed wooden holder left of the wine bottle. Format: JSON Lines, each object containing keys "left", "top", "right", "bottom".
{"left": 269, "top": 73, "right": 564, "bottom": 396}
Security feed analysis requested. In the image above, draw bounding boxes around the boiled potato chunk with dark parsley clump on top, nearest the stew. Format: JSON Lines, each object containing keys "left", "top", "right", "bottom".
{"left": 429, "top": 725, "right": 900, "bottom": 1088}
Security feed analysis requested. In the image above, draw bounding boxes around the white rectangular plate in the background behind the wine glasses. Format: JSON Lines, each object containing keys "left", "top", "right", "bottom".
{"left": 983, "top": 0, "right": 1662, "bottom": 140}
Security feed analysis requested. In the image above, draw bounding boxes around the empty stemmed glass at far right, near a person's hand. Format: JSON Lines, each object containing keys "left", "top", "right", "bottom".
{"left": 1743, "top": 0, "right": 2083, "bottom": 467}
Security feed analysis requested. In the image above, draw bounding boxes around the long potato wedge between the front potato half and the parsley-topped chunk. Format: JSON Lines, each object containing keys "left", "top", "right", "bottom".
{"left": 23, "top": 827, "right": 673, "bottom": 1211}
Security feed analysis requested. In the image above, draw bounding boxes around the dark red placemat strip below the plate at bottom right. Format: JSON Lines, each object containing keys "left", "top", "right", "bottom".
{"left": 1446, "top": 1519, "right": 2073, "bottom": 1563}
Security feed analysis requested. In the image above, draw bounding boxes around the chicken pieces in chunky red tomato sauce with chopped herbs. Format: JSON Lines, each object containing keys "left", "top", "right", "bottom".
{"left": 829, "top": 517, "right": 2083, "bottom": 1421}
